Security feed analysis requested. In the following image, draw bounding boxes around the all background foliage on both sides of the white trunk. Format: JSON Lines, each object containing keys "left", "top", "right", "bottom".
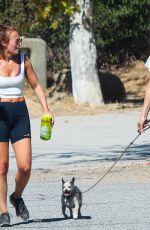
{"left": 0, "top": 0, "right": 150, "bottom": 72}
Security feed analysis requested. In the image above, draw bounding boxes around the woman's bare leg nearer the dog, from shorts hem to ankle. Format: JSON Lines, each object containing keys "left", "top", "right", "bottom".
{"left": 13, "top": 138, "right": 32, "bottom": 198}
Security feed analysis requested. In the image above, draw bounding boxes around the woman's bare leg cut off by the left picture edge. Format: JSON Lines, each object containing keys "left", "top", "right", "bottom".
{"left": 0, "top": 142, "right": 9, "bottom": 213}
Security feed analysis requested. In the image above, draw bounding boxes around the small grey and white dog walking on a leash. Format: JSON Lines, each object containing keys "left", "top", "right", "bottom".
{"left": 61, "top": 177, "right": 82, "bottom": 220}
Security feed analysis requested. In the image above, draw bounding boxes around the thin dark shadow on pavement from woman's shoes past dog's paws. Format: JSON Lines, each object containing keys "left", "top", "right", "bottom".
{"left": 10, "top": 216, "right": 92, "bottom": 227}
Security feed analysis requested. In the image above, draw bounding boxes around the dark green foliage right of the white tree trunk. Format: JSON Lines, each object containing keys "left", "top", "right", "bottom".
{"left": 93, "top": 0, "right": 150, "bottom": 65}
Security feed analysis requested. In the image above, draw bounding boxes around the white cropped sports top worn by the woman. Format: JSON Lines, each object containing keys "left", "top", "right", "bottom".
{"left": 0, "top": 53, "right": 24, "bottom": 98}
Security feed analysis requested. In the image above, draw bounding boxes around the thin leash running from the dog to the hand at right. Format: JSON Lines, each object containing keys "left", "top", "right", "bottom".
{"left": 82, "top": 120, "right": 150, "bottom": 193}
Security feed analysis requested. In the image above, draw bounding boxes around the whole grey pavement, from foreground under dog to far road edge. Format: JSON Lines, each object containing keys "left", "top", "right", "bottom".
{"left": 8, "top": 112, "right": 150, "bottom": 230}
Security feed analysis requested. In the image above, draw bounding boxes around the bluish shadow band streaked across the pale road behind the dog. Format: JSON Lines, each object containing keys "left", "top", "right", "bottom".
{"left": 33, "top": 143, "right": 150, "bottom": 165}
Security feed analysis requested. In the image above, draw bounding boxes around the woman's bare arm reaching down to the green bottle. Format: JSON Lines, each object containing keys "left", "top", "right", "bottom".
{"left": 25, "top": 56, "right": 54, "bottom": 125}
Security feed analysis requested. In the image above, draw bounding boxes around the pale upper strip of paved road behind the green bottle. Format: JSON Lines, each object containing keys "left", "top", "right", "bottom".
{"left": 10, "top": 112, "right": 150, "bottom": 169}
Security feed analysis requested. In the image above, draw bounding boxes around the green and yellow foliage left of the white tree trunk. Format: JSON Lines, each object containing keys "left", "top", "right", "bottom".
{"left": 0, "top": 0, "right": 73, "bottom": 72}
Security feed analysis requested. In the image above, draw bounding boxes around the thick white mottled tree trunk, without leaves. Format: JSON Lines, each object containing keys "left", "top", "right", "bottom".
{"left": 70, "top": 0, "right": 103, "bottom": 106}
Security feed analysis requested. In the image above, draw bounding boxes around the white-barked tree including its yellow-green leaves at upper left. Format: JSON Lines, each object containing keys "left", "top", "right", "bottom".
{"left": 29, "top": 0, "right": 103, "bottom": 106}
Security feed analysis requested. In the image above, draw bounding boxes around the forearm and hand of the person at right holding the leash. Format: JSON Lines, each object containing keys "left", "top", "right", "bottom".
{"left": 137, "top": 79, "right": 150, "bottom": 131}
